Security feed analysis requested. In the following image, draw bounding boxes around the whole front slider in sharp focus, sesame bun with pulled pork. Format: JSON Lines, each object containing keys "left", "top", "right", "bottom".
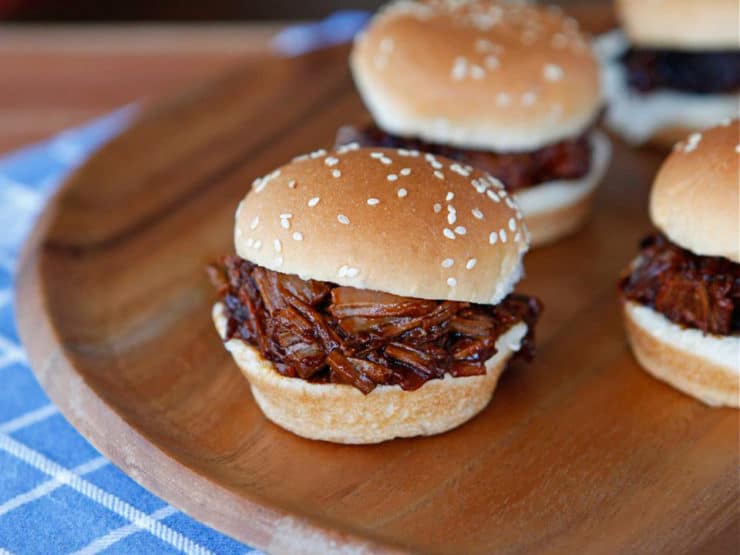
{"left": 210, "top": 145, "right": 541, "bottom": 443}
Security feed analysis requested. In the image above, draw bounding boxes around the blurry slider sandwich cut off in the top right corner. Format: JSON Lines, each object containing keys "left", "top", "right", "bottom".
{"left": 597, "top": 0, "right": 740, "bottom": 146}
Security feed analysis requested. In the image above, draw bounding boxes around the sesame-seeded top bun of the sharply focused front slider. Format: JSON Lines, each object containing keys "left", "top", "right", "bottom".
{"left": 234, "top": 144, "right": 528, "bottom": 304}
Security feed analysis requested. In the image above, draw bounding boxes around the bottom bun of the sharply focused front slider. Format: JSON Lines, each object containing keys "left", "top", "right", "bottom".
{"left": 213, "top": 303, "right": 527, "bottom": 444}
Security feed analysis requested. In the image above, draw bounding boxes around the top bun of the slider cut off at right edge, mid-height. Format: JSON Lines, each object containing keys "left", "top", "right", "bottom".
{"left": 650, "top": 120, "right": 740, "bottom": 262}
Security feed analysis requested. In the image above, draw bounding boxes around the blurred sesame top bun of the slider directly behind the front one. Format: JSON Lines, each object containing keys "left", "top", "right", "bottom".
{"left": 350, "top": 0, "right": 602, "bottom": 151}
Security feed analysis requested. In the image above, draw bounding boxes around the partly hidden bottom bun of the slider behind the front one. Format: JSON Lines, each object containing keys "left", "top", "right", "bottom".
{"left": 514, "top": 131, "right": 611, "bottom": 247}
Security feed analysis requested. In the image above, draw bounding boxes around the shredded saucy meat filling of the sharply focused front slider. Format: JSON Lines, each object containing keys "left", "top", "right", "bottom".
{"left": 209, "top": 256, "right": 542, "bottom": 394}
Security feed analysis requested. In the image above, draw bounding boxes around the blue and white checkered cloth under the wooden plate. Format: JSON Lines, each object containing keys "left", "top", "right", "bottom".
{"left": 0, "top": 12, "right": 367, "bottom": 555}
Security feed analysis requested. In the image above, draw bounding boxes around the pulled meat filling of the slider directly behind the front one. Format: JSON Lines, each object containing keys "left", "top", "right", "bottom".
{"left": 336, "top": 125, "right": 591, "bottom": 191}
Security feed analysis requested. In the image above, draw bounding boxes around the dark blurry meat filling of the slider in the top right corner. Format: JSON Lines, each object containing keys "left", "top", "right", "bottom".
{"left": 622, "top": 48, "right": 740, "bottom": 94}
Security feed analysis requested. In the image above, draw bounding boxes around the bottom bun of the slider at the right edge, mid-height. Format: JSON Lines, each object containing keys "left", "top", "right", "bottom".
{"left": 624, "top": 301, "right": 740, "bottom": 408}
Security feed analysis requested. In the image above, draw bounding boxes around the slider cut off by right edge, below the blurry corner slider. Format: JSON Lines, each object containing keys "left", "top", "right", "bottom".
{"left": 619, "top": 120, "right": 740, "bottom": 407}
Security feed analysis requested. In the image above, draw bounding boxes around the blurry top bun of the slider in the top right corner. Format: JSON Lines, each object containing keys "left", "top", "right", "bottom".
{"left": 617, "top": 0, "right": 740, "bottom": 50}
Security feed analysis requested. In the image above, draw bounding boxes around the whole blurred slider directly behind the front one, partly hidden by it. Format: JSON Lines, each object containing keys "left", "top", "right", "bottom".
{"left": 344, "top": 0, "right": 610, "bottom": 245}
